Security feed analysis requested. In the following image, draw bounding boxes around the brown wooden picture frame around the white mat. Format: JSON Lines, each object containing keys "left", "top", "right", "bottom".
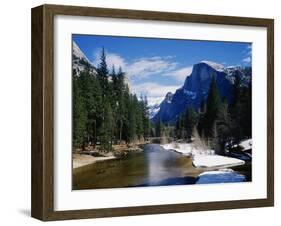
{"left": 31, "top": 5, "right": 274, "bottom": 221}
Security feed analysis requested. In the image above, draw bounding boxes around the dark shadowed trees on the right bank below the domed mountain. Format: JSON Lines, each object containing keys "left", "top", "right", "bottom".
{"left": 174, "top": 73, "right": 252, "bottom": 153}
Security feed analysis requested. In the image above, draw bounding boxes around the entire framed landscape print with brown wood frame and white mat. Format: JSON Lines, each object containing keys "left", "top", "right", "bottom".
{"left": 32, "top": 5, "right": 274, "bottom": 221}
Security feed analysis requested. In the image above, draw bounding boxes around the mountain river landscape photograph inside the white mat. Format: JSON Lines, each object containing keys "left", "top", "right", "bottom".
{"left": 71, "top": 34, "right": 252, "bottom": 190}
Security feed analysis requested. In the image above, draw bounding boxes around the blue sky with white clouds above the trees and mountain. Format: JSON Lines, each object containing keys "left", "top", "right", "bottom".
{"left": 72, "top": 35, "right": 252, "bottom": 104}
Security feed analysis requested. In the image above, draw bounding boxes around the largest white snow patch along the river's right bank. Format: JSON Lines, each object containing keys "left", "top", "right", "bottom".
{"left": 161, "top": 143, "right": 245, "bottom": 168}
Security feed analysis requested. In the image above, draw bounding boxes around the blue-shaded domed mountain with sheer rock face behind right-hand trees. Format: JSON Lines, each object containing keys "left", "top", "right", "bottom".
{"left": 152, "top": 62, "right": 251, "bottom": 122}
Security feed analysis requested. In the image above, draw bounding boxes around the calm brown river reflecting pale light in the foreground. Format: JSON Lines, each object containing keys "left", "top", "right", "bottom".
{"left": 72, "top": 144, "right": 251, "bottom": 190}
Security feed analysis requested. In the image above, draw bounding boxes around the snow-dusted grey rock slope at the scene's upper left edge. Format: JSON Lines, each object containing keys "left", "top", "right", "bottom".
{"left": 72, "top": 41, "right": 96, "bottom": 76}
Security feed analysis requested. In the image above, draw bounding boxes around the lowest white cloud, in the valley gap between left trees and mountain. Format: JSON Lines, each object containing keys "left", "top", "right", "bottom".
{"left": 131, "top": 82, "right": 179, "bottom": 105}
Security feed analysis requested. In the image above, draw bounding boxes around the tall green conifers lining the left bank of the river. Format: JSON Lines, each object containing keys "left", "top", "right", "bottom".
{"left": 72, "top": 48, "right": 151, "bottom": 151}
